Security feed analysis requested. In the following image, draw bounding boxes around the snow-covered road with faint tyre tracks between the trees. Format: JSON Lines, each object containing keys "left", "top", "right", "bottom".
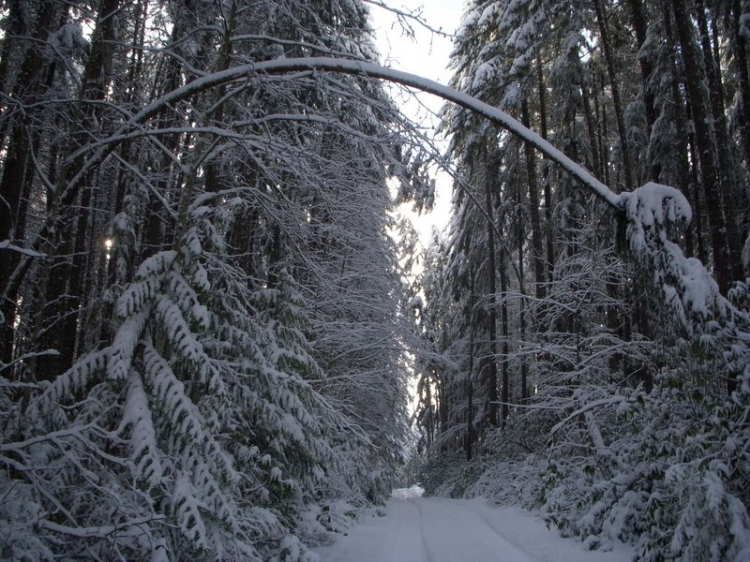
{"left": 317, "top": 498, "right": 632, "bottom": 562}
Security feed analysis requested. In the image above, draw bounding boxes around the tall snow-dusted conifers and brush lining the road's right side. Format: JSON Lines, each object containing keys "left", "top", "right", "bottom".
{"left": 418, "top": 0, "right": 748, "bottom": 560}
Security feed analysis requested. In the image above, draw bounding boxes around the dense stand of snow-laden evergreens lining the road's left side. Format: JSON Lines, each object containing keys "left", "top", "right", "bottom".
{"left": 0, "top": 0, "right": 414, "bottom": 560}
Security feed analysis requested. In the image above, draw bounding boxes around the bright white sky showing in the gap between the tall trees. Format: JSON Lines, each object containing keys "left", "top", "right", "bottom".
{"left": 370, "top": 0, "right": 464, "bottom": 246}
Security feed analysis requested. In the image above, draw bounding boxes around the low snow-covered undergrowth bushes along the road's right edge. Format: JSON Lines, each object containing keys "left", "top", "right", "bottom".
{"left": 426, "top": 372, "right": 750, "bottom": 562}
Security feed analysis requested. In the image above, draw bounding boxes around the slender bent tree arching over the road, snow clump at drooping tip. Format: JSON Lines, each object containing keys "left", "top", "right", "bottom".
{"left": 4, "top": 57, "right": 750, "bottom": 393}
